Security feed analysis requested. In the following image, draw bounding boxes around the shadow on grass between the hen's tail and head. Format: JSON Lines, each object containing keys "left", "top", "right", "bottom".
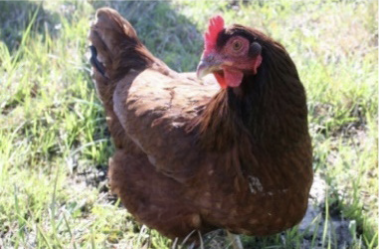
{"left": 93, "top": 0, "right": 203, "bottom": 71}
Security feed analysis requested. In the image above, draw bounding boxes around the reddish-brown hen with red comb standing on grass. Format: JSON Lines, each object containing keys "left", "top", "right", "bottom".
{"left": 90, "top": 8, "right": 313, "bottom": 243}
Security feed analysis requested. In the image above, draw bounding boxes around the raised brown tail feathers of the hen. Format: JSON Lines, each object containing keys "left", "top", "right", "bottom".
{"left": 89, "top": 8, "right": 154, "bottom": 81}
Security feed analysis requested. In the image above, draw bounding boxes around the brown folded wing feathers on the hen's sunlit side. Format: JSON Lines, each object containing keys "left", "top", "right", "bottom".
{"left": 113, "top": 69, "right": 219, "bottom": 182}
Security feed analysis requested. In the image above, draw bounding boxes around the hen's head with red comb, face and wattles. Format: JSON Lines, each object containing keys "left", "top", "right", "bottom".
{"left": 197, "top": 16, "right": 262, "bottom": 88}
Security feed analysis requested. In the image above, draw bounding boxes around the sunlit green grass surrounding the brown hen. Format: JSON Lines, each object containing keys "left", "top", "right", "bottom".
{"left": 0, "top": 0, "right": 379, "bottom": 249}
